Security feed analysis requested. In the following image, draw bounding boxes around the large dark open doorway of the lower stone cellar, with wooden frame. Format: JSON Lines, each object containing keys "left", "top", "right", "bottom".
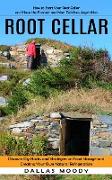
{"left": 60, "top": 118, "right": 91, "bottom": 155}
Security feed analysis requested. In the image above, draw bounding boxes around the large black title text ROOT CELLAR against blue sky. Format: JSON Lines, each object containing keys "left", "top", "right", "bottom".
{"left": 5, "top": 19, "right": 108, "bottom": 35}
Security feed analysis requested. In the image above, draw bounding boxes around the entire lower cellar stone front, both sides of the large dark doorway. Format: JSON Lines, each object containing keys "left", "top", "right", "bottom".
{"left": 9, "top": 113, "right": 112, "bottom": 155}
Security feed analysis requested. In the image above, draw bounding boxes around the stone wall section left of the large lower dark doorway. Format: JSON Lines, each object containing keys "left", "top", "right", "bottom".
{"left": 9, "top": 113, "right": 61, "bottom": 154}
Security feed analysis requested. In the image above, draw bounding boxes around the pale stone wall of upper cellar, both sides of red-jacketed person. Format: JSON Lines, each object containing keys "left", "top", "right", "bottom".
{"left": 10, "top": 44, "right": 69, "bottom": 68}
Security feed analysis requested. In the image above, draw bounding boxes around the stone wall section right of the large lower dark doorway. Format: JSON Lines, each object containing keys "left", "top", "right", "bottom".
{"left": 90, "top": 115, "right": 112, "bottom": 155}
